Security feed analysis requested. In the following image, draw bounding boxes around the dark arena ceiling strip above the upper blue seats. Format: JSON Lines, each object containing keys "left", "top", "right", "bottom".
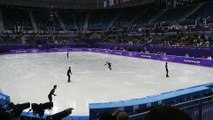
{"left": 0, "top": 0, "right": 155, "bottom": 9}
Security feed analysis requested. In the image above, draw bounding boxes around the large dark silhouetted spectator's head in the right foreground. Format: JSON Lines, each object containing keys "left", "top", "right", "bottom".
{"left": 144, "top": 106, "right": 192, "bottom": 120}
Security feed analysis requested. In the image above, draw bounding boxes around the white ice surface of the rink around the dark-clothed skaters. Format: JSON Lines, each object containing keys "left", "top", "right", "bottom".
{"left": 0, "top": 52, "right": 213, "bottom": 115}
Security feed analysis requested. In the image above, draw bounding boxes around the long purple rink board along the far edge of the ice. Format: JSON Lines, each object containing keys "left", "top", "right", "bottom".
{"left": 7, "top": 48, "right": 213, "bottom": 67}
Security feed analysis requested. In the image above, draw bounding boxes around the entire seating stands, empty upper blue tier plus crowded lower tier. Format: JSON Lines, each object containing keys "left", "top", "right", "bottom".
{"left": 0, "top": 1, "right": 213, "bottom": 58}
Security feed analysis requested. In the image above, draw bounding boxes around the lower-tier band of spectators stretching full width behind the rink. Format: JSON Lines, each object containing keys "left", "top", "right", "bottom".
{"left": 0, "top": 31, "right": 213, "bottom": 47}
